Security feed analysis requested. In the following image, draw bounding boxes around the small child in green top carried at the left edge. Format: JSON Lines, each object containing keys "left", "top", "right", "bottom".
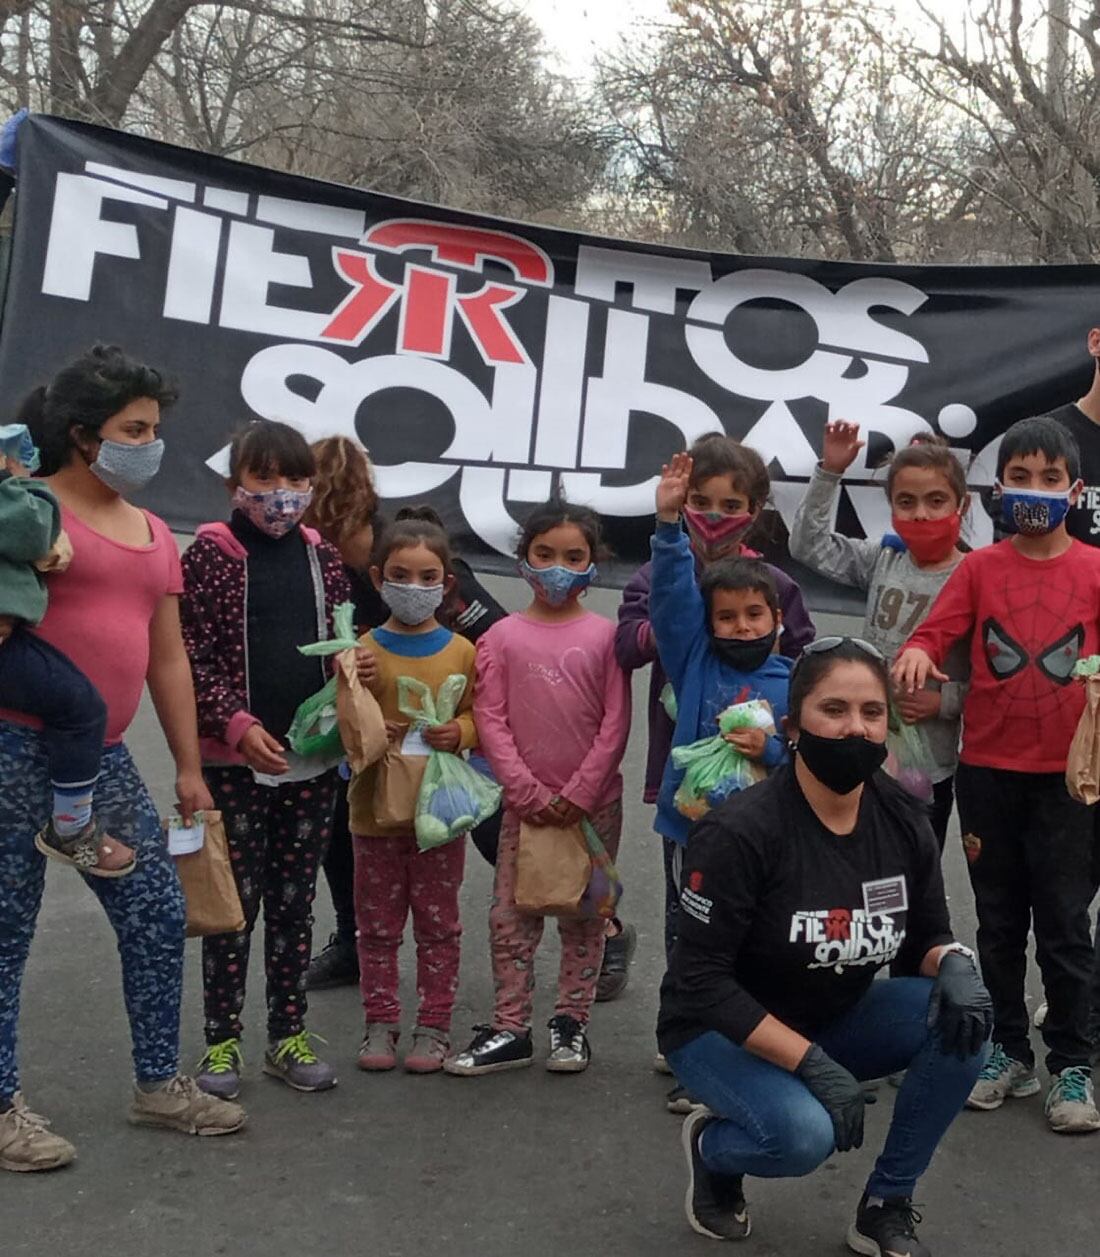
{"left": 0, "top": 424, "right": 135, "bottom": 877}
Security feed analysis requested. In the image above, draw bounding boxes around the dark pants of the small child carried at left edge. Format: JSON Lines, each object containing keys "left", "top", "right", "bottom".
{"left": 0, "top": 627, "right": 107, "bottom": 788}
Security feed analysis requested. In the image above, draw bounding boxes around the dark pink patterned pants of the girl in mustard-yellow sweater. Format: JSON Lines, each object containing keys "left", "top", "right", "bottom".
{"left": 353, "top": 833, "right": 466, "bottom": 1031}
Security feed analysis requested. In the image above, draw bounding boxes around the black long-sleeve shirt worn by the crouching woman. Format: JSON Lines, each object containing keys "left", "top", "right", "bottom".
{"left": 657, "top": 764, "right": 952, "bottom": 1053}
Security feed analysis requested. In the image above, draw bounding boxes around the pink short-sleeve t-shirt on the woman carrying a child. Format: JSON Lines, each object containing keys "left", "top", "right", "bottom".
{"left": 0, "top": 507, "right": 184, "bottom": 742}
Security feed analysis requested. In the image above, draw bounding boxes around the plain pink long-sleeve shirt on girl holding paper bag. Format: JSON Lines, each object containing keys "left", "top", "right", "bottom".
{"left": 474, "top": 611, "right": 630, "bottom": 816}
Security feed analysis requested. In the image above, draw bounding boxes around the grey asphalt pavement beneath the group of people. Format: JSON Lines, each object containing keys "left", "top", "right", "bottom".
{"left": 0, "top": 581, "right": 1100, "bottom": 1257}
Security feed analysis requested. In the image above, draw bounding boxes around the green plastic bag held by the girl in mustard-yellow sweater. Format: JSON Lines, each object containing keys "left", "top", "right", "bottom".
{"left": 397, "top": 672, "right": 502, "bottom": 851}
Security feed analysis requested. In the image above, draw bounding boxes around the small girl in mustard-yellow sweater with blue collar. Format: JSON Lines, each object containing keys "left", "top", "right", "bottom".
{"left": 348, "top": 519, "right": 478, "bottom": 1073}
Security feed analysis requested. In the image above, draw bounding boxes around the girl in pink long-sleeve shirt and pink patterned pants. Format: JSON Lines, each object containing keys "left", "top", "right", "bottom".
{"left": 444, "top": 500, "right": 630, "bottom": 1075}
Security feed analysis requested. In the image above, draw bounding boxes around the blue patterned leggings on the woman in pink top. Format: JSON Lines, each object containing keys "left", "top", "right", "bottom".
{"left": 0, "top": 722, "right": 185, "bottom": 1100}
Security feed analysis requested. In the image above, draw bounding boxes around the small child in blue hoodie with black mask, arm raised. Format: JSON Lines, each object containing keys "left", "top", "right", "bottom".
{"left": 650, "top": 454, "right": 792, "bottom": 847}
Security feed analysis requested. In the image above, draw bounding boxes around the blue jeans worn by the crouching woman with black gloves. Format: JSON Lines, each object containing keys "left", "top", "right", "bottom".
{"left": 669, "top": 978, "right": 987, "bottom": 1198}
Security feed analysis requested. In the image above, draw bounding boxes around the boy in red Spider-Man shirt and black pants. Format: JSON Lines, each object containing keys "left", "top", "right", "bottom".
{"left": 894, "top": 417, "right": 1100, "bottom": 1133}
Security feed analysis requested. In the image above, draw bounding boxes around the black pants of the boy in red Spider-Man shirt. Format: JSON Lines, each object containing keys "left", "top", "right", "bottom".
{"left": 955, "top": 764, "right": 1094, "bottom": 1073}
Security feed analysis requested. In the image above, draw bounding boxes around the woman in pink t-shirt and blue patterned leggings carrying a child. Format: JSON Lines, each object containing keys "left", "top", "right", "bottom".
{"left": 0, "top": 346, "right": 244, "bottom": 1170}
